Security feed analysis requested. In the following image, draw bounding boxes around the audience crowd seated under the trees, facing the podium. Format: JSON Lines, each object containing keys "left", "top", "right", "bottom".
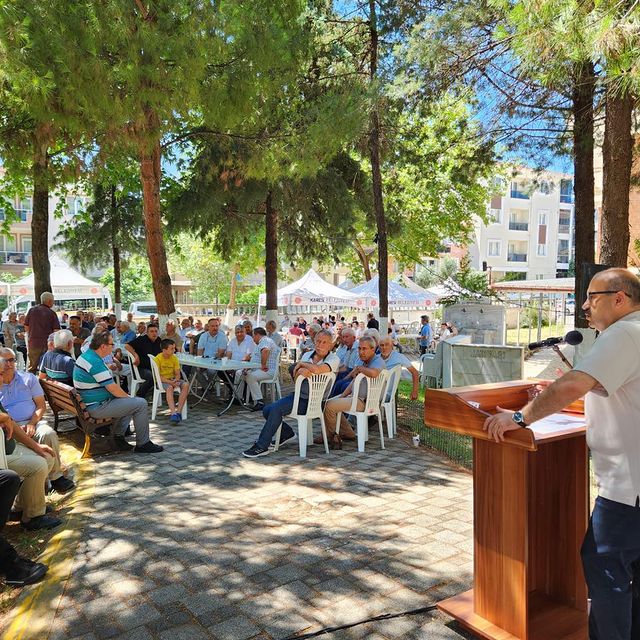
{"left": 0, "top": 293, "right": 444, "bottom": 585}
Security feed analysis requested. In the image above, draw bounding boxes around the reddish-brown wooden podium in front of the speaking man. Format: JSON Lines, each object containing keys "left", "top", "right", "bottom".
{"left": 424, "top": 380, "right": 589, "bottom": 640}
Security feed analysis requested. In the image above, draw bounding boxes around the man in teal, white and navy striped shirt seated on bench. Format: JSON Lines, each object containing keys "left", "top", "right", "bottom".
{"left": 73, "top": 331, "right": 163, "bottom": 453}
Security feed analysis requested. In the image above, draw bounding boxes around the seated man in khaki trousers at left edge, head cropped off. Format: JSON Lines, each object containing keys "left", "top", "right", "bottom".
{"left": 0, "top": 404, "right": 62, "bottom": 531}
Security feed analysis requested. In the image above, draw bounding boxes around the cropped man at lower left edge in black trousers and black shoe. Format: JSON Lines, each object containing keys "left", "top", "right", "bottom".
{"left": 0, "top": 464, "right": 47, "bottom": 587}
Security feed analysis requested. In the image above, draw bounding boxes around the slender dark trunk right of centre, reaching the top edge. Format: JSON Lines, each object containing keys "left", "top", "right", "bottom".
{"left": 369, "top": 0, "right": 389, "bottom": 336}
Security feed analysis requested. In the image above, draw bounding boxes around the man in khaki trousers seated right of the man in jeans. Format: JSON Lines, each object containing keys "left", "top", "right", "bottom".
{"left": 322, "top": 336, "right": 386, "bottom": 442}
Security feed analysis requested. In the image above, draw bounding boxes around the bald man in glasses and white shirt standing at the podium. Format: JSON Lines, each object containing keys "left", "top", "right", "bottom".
{"left": 484, "top": 269, "right": 640, "bottom": 640}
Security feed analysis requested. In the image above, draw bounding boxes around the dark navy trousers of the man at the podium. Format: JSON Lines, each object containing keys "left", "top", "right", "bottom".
{"left": 581, "top": 496, "right": 640, "bottom": 640}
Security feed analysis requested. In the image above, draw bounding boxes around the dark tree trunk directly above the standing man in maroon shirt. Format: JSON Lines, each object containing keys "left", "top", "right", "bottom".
{"left": 31, "top": 126, "right": 52, "bottom": 300}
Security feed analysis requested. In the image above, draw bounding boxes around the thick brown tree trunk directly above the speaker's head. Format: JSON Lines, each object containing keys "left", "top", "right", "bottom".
{"left": 600, "top": 89, "right": 634, "bottom": 267}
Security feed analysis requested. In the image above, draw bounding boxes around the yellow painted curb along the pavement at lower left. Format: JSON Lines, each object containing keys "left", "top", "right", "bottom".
{"left": 2, "top": 448, "right": 95, "bottom": 640}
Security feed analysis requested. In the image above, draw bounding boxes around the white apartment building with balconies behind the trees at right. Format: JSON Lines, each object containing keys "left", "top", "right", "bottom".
{"left": 469, "top": 168, "right": 575, "bottom": 282}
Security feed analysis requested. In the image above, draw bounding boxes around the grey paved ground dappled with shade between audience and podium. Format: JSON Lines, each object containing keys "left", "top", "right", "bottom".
{"left": 50, "top": 405, "right": 472, "bottom": 640}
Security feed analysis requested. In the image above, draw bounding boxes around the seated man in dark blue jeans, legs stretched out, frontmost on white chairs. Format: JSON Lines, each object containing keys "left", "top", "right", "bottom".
{"left": 242, "top": 331, "right": 340, "bottom": 458}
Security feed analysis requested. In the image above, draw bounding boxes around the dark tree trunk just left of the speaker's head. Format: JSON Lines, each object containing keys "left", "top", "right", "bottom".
{"left": 572, "top": 62, "right": 596, "bottom": 328}
